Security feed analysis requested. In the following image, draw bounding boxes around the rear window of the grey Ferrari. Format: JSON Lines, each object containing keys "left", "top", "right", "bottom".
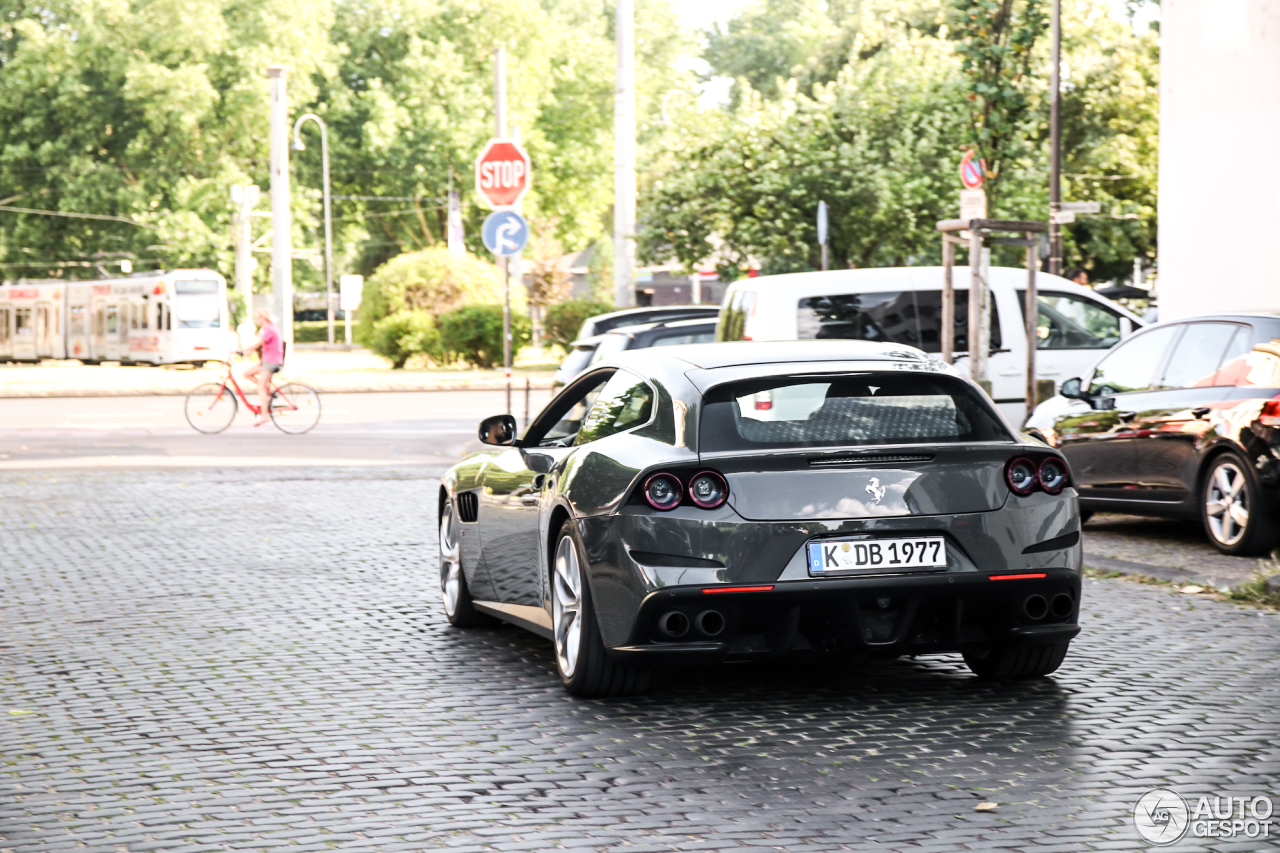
{"left": 699, "top": 373, "right": 1010, "bottom": 452}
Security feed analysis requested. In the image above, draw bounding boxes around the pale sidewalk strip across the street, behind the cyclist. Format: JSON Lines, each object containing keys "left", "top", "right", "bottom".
{"left": 0, "top": 346, "right": 553, "bottom": 398}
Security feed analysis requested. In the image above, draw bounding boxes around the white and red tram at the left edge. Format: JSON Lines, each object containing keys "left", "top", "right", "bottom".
{"left": 0, "top": 269, "right": 236, "bottom": 364}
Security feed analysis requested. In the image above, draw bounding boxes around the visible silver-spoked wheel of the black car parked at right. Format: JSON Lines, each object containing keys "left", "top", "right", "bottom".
{"left": 1199, "top": 453, "right": 1280, "bottom": 556}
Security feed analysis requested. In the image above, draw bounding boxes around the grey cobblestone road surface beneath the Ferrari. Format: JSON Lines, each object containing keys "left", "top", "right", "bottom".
{"left": 0, "top": 469, "right": 1280, "bottom": 853}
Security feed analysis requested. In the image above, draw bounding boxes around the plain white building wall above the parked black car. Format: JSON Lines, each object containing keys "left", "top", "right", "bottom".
{"left": 1157, "top": 0, "right": 1280, "bottom": 320}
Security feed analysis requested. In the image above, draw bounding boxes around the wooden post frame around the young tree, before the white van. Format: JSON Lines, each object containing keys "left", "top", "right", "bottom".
{"left": 938, "top": 219, "right": 1048, "bottom": 415}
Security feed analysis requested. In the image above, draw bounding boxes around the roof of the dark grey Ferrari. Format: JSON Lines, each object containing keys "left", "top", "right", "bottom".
{"left": 616, "top": 341, "right": 929, "bottom": 370}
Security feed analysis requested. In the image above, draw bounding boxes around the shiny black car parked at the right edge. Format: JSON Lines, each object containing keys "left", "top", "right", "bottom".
{"left": 1027, "top": 314, "right": 1280, "bottom": 555}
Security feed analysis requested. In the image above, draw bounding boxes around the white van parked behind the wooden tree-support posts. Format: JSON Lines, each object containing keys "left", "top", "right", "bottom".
{"left": 716, "top": 266, "right": 1143, "bottom": 424}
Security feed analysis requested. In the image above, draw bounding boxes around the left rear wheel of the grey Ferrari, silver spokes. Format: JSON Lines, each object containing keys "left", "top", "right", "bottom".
{"left": 550, "top": 521, "right": 649, "bottom": 698}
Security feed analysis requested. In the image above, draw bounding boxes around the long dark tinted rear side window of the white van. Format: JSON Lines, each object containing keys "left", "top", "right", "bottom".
{"left": 796, "top": 289, "right": 1001, "bottom": 352}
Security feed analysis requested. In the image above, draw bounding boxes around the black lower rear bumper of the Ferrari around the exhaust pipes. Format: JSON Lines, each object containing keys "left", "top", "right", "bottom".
{"left": 609, "top": 569, "right": 1080, "bottom": 666}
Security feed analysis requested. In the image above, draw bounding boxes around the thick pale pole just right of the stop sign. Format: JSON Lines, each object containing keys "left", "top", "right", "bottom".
{"left": 613, "top": 0, "right": 636, "bottom": 307}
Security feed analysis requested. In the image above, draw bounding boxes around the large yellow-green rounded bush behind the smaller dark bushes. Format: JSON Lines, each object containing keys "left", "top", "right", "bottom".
{"left": 356, "top": 246, "right": 512, "bottom": 346}
